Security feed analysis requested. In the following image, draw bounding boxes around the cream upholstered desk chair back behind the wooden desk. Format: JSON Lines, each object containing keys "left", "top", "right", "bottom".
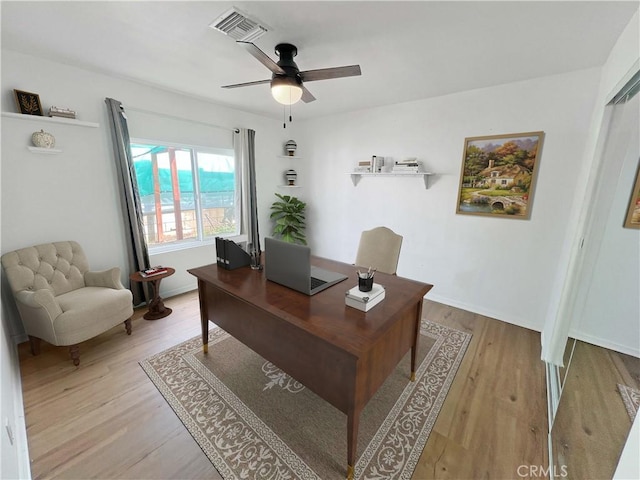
{"left": 356, "top": 227, "right": 402, "bottom": 275}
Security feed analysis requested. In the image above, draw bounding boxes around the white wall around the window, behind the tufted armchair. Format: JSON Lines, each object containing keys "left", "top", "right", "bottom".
{"left": 1, "top": 50, "right": 289, "bottom": 315}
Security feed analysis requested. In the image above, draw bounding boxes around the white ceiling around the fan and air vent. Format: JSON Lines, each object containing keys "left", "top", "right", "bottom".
{"left": 1, "top": 0, "right": 638, "bottom": 118}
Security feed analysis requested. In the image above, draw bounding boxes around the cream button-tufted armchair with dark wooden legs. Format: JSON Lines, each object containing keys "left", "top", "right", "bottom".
{"left": 2, "top": 241, "right": 133, "bottom": 366}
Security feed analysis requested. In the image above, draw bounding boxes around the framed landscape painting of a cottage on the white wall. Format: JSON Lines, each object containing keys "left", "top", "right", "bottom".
{"left": 456, "top": 132, "right": 544, "bottom": 219}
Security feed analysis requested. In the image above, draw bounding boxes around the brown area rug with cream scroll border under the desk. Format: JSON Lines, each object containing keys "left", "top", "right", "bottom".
{"left": 140, "top": 320, "right": 471, "bottom": 480}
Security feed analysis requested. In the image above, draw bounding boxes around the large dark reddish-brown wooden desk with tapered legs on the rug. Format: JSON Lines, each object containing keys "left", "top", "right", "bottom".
{"left": 189, "top": 257, "right": 432, "bottom": 478}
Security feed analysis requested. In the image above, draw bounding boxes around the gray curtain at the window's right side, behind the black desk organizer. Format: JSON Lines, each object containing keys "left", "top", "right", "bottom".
{"left": 233, "top": 128, "right": 262, "bottom": 268}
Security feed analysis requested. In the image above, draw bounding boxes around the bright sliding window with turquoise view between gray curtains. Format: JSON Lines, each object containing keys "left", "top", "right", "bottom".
{"left": 131, "top": 140, "right": 240, "bottom": 250}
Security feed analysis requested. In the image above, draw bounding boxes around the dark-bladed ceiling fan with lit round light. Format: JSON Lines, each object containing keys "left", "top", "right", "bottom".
{"left": 222, "top": 41, "right": 361, "bottom": 105}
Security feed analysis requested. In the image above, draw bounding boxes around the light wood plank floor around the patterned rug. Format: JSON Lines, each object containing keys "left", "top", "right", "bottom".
{"left": 19, "top": 292, "right": 547, "bottom": 480}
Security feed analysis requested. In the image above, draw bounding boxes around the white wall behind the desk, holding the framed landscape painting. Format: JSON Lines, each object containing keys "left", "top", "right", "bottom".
{"left": 299, "top": 69, "right": 599, "bottom": 330}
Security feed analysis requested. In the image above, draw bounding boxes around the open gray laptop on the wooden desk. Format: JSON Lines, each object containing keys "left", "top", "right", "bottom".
{"left": 264, "top": 237, "right": 348, "bottom": 295}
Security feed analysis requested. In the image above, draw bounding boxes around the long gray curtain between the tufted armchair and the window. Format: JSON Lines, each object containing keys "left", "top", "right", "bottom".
{"left": 105, "top": 98, "right": 151, "bottom": 305}
